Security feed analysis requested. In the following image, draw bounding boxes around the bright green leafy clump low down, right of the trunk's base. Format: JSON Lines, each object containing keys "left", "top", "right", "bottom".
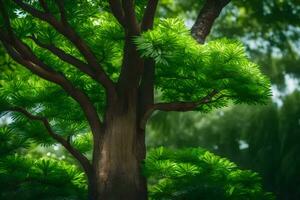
{"left": 144, "top": 148, "right": 274, "bottom": 200}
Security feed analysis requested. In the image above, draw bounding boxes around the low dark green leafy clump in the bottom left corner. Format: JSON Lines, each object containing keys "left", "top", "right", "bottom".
{"left": 0, "top": 155, "right": 86, "bottom": 200}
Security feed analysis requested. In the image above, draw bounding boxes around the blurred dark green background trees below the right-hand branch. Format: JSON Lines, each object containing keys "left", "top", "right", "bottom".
{"left": 147, "top": 91, "right": 300, "bottom": 200}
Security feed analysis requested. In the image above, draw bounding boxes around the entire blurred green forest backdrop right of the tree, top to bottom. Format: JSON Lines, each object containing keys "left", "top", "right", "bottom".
{"left": 147, "top": 0, "right": 300, "bottom": 200}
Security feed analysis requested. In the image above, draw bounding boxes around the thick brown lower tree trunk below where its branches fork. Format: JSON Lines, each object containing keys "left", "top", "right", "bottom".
{"left": 89, "top": 95, "right": 147, "bottom": 200}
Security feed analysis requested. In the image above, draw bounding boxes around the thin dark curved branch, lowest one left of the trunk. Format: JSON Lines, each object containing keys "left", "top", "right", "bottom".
{"left": 7, "top": 107, "right": 92, "bottom": 174}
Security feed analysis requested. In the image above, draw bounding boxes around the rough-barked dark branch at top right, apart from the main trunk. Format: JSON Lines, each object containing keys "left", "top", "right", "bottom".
{"left": 192, "top": 0, "right": 230, "bottom": 43}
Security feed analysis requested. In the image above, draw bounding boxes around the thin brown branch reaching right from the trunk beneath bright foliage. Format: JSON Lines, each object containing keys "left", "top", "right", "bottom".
{"left": 140, "top": 90, "right": 219, "bottom": 129}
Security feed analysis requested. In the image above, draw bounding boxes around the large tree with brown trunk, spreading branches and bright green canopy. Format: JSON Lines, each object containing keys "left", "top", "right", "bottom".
{"left": 0, "top": 0, "right": 270, "bottom": 200}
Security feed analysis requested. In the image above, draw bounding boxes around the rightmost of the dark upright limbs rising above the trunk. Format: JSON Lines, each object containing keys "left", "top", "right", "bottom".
{"left": 141, "top": 0, "right": 158, "bottom": 31}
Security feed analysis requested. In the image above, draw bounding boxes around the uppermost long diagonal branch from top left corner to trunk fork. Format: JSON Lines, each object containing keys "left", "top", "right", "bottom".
{"left": 13, "top": 0, "right": 115, "bottom": 97}
